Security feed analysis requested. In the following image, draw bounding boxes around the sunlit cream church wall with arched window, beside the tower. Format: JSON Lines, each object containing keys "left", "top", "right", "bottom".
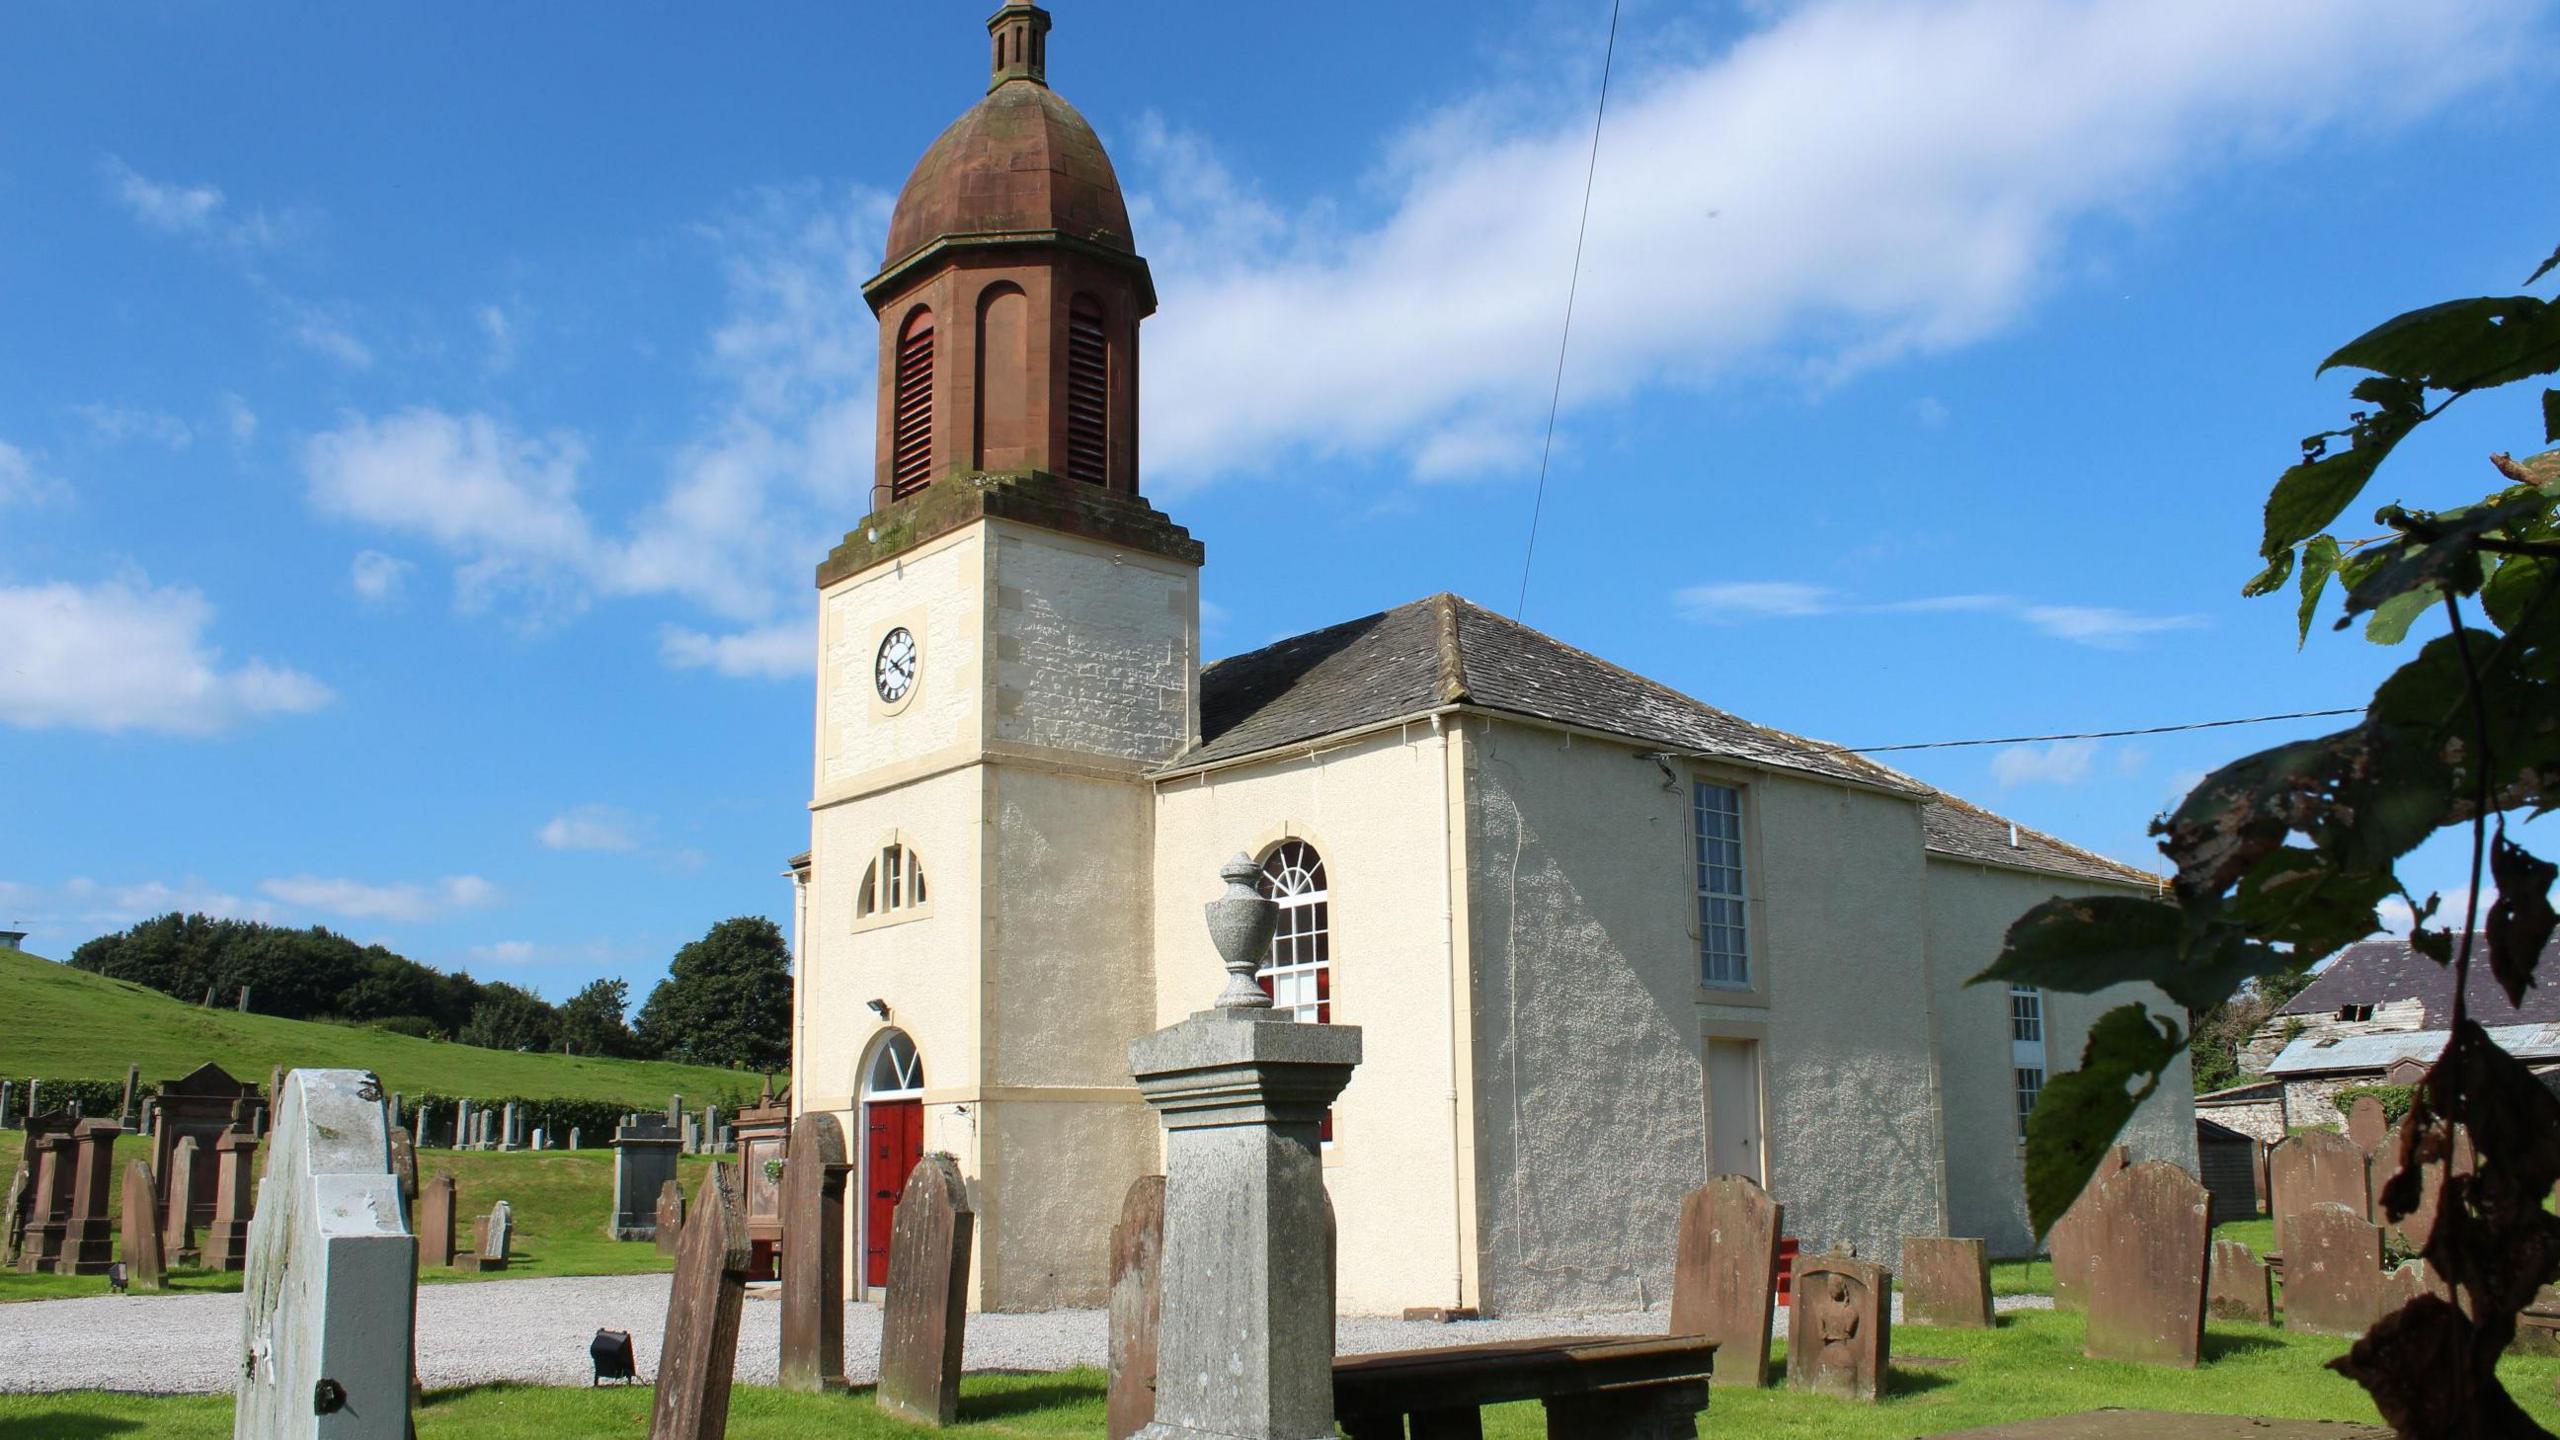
{"left": 1152, "top": 723, "right": 1477, "bottom": 1314}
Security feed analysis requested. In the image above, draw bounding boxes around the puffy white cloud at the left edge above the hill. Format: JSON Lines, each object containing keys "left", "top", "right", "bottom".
{"left": 0, "top": 577, "right": 333, "bottom": 735}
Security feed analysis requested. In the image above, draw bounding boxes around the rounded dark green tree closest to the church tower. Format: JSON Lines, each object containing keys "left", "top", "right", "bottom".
{"left": 640, "top": 915, "right": 791, "bottom": 1071}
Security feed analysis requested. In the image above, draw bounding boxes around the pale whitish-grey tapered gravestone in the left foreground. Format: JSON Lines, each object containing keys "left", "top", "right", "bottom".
{"left": 233, "top": 1068, "right": 417, "bottom": 1440}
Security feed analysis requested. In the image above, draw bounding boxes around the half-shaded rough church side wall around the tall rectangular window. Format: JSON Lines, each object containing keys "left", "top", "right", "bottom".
{"left": 1467, "top": 723, "right": 1943, "bottom": 1312}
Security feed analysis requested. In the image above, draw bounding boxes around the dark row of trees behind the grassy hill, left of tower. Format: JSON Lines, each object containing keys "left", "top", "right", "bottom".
{"left": 69, "top": 912, "right": 791, "bottom": 1071}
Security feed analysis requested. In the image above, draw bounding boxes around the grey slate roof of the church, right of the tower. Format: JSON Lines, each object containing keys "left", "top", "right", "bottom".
{"left": 1165, "top": 594, "right": 2156, "bottom": 884}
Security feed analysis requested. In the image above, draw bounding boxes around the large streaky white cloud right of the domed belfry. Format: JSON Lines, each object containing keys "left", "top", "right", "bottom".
{"left": 1121, "top": 0, "right": 2527, "bottom": 482}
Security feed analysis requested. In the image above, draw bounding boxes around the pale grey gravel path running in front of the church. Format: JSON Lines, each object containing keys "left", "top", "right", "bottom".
{"left": 0, "top": 1273, "right": 2053, "bottom": 1391}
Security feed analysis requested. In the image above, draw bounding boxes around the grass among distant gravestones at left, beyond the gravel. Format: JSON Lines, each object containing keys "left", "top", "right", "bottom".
{"left": 0, "top": 1133, "right": 712, "bottom": 1301}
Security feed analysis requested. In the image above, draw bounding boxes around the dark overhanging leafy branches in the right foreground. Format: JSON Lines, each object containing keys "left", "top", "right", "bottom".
{"left": 1976, "top": 240, "right": 2560, "bottom": 1440}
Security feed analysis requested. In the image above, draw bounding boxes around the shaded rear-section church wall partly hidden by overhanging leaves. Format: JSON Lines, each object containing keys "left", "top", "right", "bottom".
{"left": 1928, "top": 856, "right": 2196, "bottom": 1258}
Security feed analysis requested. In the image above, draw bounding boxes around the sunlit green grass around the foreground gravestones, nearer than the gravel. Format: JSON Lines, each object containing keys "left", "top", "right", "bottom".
{"left": 0, "top": 1312, "right": 2560, "bottom": 1440}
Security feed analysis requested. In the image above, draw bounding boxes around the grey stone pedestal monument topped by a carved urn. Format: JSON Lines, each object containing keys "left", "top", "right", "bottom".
{"left": 1129, "top": 856, "right": 1362, "bottom": 1440}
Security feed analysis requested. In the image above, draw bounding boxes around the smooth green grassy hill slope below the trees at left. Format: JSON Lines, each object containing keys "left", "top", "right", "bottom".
{"left": 0, "top": 951, "right": 758, "bottom": 1109}
